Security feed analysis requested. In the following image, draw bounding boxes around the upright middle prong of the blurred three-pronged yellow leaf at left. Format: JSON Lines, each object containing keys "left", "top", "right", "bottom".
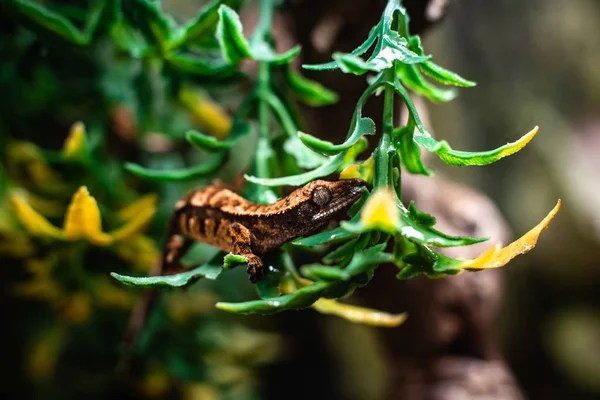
{"left": 64, "top": 186, "right": 112, "bottom": 246}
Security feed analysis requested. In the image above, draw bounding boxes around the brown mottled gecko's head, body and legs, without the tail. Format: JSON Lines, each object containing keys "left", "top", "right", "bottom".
{"left": 161, "top": 179, "right": 366, "bottom": 282}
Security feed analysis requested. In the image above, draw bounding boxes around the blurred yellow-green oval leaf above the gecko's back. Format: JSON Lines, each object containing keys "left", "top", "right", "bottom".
{"left": 179, "top": 88, "right": 231, "bottom": 139}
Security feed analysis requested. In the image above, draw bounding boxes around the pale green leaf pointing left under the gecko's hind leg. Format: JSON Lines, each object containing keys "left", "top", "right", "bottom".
{"left": 110, "top": 263, "right": 222, "bottom": 288}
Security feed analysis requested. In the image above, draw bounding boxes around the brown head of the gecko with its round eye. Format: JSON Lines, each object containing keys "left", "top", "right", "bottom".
{"left": 303, "top": 179, "right": 367, "bottom": 223}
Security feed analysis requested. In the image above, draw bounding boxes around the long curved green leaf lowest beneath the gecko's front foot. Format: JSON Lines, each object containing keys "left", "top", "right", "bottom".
{"left": 216, "top": 282, "right": 328, "bottom": 315}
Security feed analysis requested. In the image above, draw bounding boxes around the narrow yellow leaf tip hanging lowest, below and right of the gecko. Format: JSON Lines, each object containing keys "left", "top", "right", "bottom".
{"left": 311, "top": 299, "right": 407, "bottom": 328}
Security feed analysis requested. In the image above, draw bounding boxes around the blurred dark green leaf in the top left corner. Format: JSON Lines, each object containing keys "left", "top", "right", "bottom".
{"left": 11, "top": 0, "right": 106, "bottom": 45}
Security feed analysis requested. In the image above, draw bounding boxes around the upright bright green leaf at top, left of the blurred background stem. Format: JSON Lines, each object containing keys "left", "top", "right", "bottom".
{"left": 217, "top": 5, "right": 252, "bottom": 65}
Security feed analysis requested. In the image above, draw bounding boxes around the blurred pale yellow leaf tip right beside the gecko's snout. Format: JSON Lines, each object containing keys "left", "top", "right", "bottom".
{"left": 360, "top": 188, "right": 400, "bottom": 232}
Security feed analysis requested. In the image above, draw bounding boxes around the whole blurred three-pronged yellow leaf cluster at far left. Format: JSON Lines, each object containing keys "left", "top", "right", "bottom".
{"left": 10, "top": 186, "right": 156, "bottom": 246}
